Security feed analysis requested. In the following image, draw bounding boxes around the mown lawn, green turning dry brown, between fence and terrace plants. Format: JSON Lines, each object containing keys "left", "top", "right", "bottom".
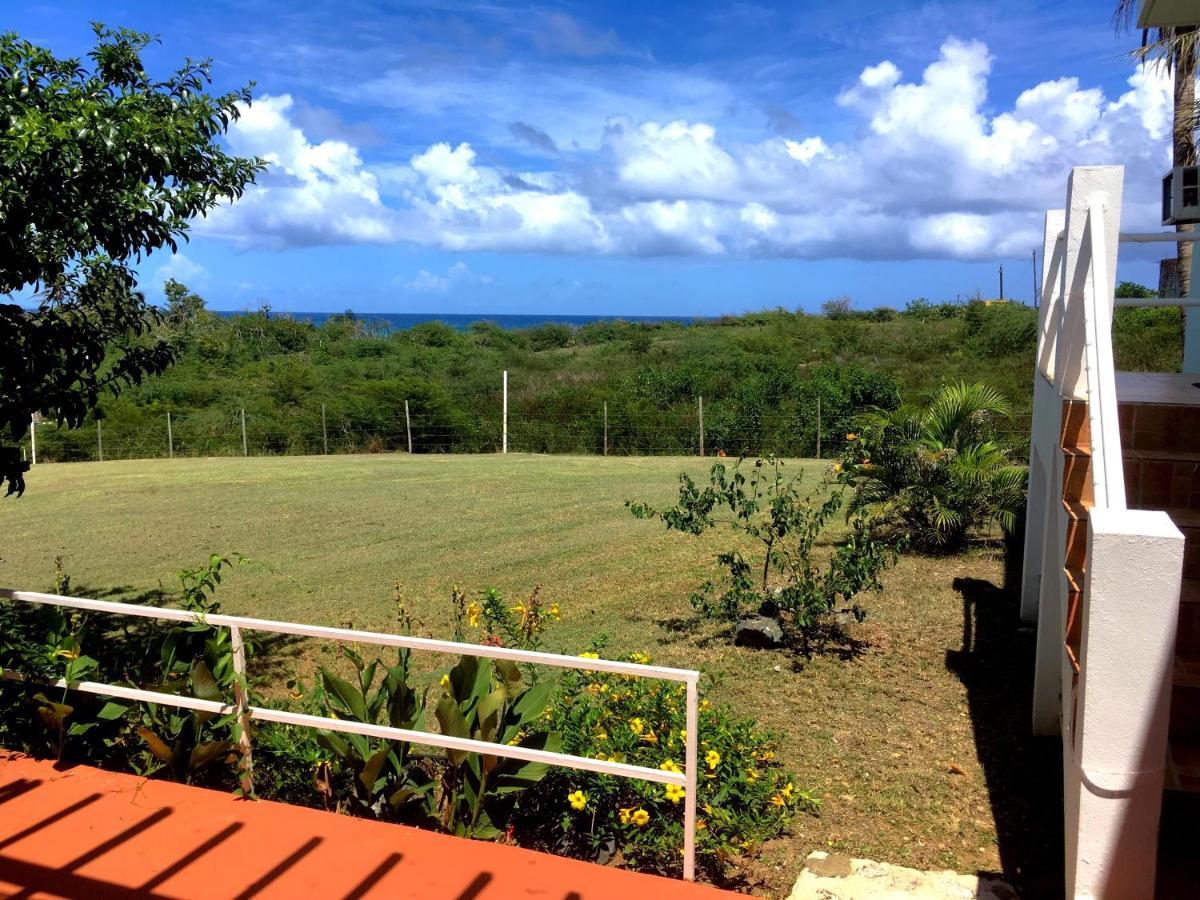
{"left": 7, "top": 455, "right": 1061, "bottom": 896}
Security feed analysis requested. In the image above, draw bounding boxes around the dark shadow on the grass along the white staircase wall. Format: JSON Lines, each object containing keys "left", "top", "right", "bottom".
{"left": 946, "top": 559, "right": 1063, "bottom": 898}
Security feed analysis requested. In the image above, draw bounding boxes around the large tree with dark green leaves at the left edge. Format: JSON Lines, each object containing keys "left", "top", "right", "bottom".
{"left": 0, "top": 24, "right": 264, "bottom": 494}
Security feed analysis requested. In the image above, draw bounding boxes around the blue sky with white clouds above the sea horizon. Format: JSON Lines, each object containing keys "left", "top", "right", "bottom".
{"left": 11, "top": 0, "right": 1170, "bottom": 314}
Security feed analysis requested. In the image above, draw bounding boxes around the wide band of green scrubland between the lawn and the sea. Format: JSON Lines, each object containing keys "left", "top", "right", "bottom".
{"left": 25, "top": 282, "right": 1181, "bottom": 460}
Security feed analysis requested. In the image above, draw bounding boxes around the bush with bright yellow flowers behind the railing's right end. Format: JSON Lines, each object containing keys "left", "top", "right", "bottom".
{"left": 516, "top": 644, "right": 817, "bottom": 877}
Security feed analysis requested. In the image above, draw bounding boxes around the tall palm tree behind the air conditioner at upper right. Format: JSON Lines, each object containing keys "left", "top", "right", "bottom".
{"left": 1112, "top": 0, "right": 1200, "bottom": 296}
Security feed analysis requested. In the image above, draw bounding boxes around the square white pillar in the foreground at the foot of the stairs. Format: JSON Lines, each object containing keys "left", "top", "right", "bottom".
{"left": 1064, "top": 509, "right": 1183, "bottom": 900}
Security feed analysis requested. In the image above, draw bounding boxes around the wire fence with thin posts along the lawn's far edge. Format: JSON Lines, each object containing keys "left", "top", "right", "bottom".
{"left": 23, "top": 398, "right": 1028, "bottom": 462}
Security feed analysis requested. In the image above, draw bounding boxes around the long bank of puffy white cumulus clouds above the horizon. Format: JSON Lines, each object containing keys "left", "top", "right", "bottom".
{"left": 204, "top": 38, "right": 1171, "bottom": 260}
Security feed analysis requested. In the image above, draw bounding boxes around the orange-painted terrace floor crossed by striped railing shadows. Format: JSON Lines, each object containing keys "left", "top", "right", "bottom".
{"left": 0, "top": 752, "right": 736, "bottom": 900}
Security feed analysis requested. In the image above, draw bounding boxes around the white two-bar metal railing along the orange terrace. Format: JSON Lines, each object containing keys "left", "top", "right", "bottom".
{"left": 0, "top": 588, "right": 700, "bottom": 881}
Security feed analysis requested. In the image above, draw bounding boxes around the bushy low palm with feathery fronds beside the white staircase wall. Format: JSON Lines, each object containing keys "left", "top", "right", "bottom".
{"left": 839, "top": 382, "right": 1027, "bottom": 552}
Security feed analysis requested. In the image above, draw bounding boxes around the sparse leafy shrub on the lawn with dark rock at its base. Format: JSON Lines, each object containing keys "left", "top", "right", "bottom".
{"left": 625, "top": 460, "right": 898, "bottom": 642}
